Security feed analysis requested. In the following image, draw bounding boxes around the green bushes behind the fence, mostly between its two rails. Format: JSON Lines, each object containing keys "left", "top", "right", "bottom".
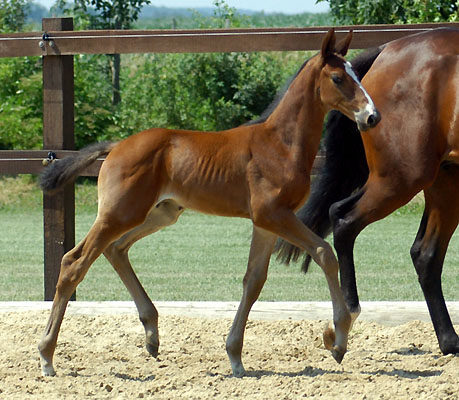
{"left": 0, "top": 0, "right": 328, "bottom": 149}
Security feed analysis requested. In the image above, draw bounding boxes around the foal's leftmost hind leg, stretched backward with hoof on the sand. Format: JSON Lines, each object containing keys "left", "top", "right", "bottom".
{"left": 38, "top": 218, "right": 133, "bottom": 376}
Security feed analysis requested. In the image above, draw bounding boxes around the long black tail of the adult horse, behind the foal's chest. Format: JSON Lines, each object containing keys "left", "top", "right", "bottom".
{"left": 275, "top": 47, "right": 383, "bottom": 272}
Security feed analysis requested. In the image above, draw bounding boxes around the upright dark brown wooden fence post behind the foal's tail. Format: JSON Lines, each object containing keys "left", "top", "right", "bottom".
{"left": 42, "top": 18, "right": 75, "bottom": 300}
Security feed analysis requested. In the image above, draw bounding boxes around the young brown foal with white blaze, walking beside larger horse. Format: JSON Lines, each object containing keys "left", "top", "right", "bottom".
{"left": 39, "top": 30, "right": 380, "bottom": 376}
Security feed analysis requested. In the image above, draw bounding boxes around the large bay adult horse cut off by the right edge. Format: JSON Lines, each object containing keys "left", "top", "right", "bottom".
{"left": 278, "top": 29, "right": 459, "bottom": 354}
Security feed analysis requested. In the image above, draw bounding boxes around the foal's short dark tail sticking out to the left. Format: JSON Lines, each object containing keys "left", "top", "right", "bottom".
{"left": 40, "top": 142, "right": 116, "bottom": 194}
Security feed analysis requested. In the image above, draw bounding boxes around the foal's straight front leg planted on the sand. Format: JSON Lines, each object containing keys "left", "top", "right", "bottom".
{"left": 226, "top": 226, "right": 276, "bottom": 377}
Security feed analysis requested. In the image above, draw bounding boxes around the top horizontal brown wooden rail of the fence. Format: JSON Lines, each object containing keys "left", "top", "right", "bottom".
{"left": 0, "top": 23, "right": 459, "bottom": 57}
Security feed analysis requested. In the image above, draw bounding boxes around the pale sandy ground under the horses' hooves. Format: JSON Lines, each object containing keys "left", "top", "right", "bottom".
{"left": 0, "top": 311, "right": 459, "bottom": 400}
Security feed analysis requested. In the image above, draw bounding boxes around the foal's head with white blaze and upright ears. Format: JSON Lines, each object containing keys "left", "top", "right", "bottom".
{"left": 317, "top": 29, "right": 381, "bottom": 131}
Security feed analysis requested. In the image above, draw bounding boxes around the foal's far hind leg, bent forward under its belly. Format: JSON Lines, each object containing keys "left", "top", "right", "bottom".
{"left": 104, "top": 200, "right": 184, "bottom": 357}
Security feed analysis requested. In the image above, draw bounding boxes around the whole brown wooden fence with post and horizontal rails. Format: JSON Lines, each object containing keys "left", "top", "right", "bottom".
{"left": 0, "top": 18, "right": 459, "bottom": 300}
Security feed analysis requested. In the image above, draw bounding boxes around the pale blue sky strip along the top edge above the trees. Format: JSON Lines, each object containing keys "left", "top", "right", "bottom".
{"left": 35, "top": 0, "right": 328, "bottom": 14}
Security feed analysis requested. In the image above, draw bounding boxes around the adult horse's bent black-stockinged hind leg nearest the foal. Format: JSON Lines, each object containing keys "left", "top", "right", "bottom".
{"left": 330, "top": 176, "right": 417, "bottom": 323}
